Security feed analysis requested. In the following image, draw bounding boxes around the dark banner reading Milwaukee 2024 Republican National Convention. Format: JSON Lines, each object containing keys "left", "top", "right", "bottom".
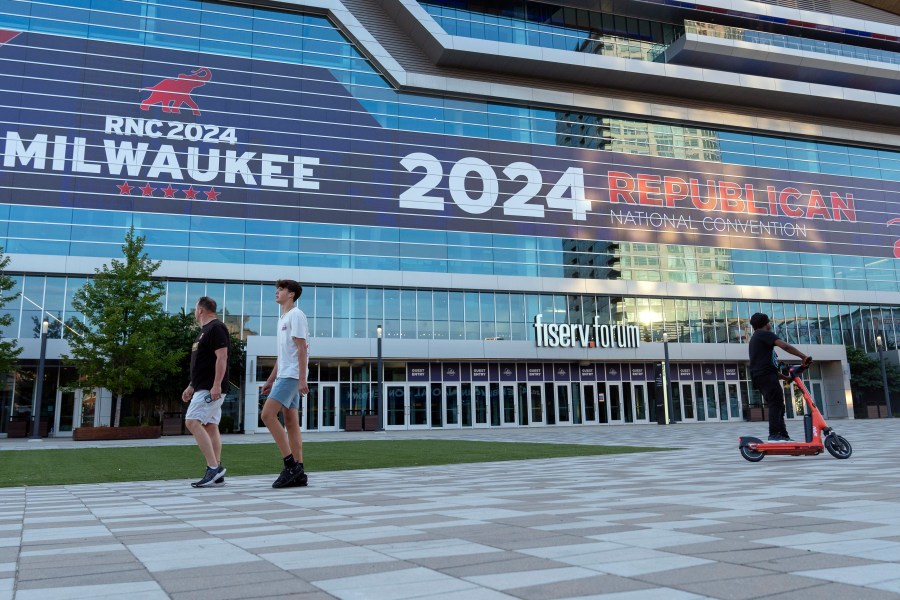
{"left": 0, "top": 30, "right": 900, "bottom": 257}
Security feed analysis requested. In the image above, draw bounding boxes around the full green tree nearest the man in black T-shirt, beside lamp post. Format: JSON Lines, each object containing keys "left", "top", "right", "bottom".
{"left": 64, "top": 227, "right": 184, "bottom": 427}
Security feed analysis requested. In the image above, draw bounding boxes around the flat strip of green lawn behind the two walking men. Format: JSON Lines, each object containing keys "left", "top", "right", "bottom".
{"left": 0, "top": 440, "right": 667, "bottom": 487}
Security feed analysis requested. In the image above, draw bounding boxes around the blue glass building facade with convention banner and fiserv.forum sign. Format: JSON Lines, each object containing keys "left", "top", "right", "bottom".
{"left": 0, "top": 0, "right": 900, "bottom": 435}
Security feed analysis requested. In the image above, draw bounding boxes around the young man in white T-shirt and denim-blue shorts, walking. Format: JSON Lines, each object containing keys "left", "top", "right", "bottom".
{"left": 262, "top": 279, "right": 309, "bottom": 488}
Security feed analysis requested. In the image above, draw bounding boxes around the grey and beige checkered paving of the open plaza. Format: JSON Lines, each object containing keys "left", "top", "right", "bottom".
{"left": 0, "top": 420, "right": 900, "bottom": 600}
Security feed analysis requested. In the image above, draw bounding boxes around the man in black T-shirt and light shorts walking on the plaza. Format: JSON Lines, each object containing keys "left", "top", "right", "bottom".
{"left": 181, "top": 296, "right": 231, "bottom": 487}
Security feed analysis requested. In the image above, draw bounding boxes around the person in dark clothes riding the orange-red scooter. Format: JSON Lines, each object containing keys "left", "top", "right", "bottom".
{"left": 749, "top": 313, "right": 812, "bottom": 442}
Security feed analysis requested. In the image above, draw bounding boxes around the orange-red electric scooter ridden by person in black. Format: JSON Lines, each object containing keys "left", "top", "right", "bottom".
{"left": 738, "top": 365, "right": 853, "bottom": 462}
